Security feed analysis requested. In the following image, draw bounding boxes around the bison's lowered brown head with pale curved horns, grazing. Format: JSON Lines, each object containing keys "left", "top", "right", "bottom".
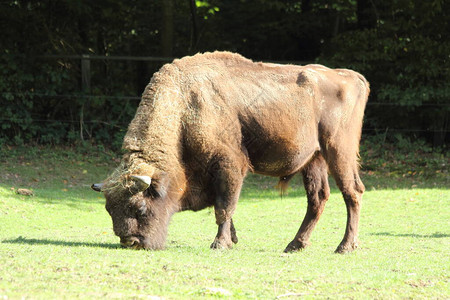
{"left": 92, "top": 158, "right": 176, "bottom": 249}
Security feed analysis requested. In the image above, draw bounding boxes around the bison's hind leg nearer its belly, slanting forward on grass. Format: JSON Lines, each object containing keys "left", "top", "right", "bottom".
{"left": 284, "top": 155, "right": 330, "bottom": 252}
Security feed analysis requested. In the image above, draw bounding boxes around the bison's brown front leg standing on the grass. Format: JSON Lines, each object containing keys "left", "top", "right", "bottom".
{"left": 211, "top": 164, "right": 244, "bottom": 249}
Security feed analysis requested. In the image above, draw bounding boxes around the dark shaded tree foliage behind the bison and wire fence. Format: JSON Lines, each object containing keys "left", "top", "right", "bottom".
{"left": 0, "top": 0, "right": 450, "bottom": 148}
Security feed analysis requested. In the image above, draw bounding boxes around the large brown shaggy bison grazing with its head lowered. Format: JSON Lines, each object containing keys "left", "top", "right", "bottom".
{"left": 92, "top": 52, "right": 369, "bottom": 253}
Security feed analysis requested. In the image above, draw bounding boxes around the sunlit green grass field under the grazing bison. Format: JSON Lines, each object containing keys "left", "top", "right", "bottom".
{"left": 0, "top": 144, "right": 450, "bottom": 299}
